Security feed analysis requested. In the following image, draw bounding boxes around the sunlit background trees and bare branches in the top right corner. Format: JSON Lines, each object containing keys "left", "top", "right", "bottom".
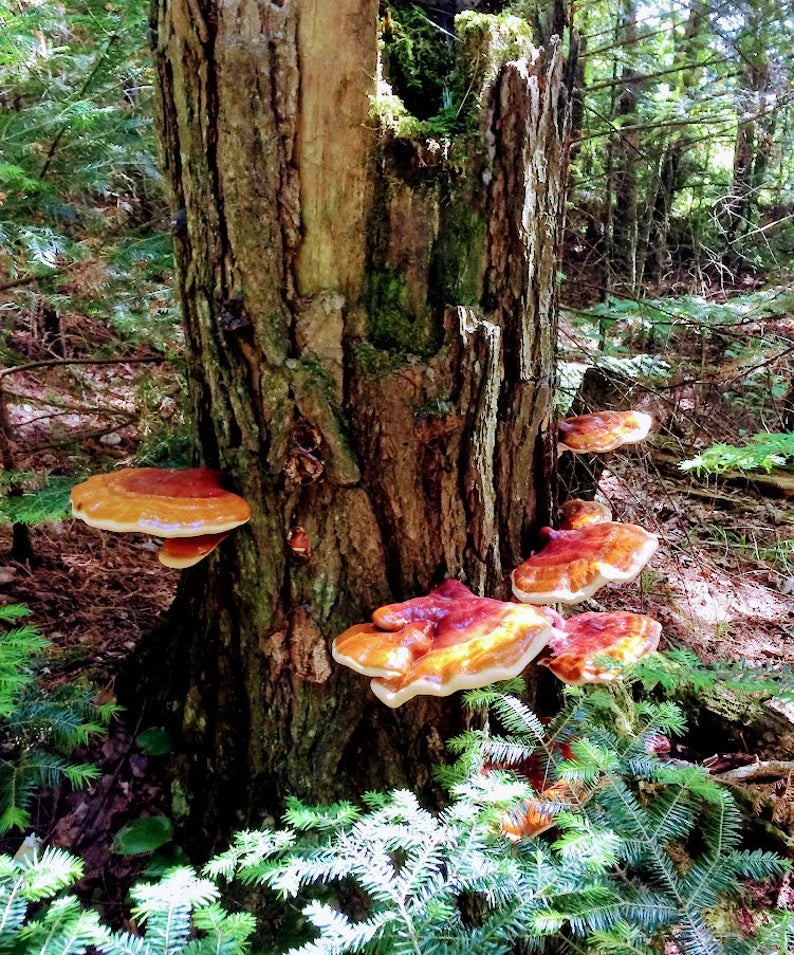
{"left": 569, "top": 0, "right": 792, "bottom": 280}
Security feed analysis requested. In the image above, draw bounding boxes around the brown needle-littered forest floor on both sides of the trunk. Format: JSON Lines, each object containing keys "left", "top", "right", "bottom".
{"left": 0, "top": 282, "right": 794, "bottom": 920}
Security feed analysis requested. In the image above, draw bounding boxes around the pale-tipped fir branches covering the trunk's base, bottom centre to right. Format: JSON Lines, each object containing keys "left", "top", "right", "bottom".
{"left": 206, "top": 688, "right": 786, "bottom": 955}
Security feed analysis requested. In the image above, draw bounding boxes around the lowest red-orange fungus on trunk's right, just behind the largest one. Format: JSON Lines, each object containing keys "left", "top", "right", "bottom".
{"left": 538, "top": 611, "right": 662, "bottom": 686}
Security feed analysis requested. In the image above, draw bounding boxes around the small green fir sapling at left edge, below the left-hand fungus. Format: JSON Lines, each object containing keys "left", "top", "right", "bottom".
{"left": 0, "top": 604, "right": 118, "bottom": 834}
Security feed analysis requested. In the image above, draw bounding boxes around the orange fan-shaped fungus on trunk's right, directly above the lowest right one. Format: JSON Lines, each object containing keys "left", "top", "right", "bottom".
{"left": 512, "top": 521, "right": 659, "bottom": 604}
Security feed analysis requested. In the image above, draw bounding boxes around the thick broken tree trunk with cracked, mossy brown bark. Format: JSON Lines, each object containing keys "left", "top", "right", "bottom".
{"left": 147, "top": 0, "right": 567, "bottom": 834}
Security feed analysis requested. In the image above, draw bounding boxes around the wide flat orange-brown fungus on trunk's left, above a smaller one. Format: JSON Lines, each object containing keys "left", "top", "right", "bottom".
{"left": 71, "top": 468, "right": 251, "bottom": 538}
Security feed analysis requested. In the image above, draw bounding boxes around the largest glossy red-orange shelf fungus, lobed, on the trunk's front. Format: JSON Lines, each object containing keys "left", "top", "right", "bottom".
{"left": 332, "top": 580, "right": 561, "bottom": 707}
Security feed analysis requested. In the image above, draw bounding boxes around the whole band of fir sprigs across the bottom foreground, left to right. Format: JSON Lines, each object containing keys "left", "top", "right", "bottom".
{"left": 0, "top": 681, "right": 794, "bottom": 955}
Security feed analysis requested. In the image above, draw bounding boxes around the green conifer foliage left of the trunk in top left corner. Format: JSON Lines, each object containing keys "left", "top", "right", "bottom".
{"left": 0, "top": 0, "right": 179, "bottom": 370}
